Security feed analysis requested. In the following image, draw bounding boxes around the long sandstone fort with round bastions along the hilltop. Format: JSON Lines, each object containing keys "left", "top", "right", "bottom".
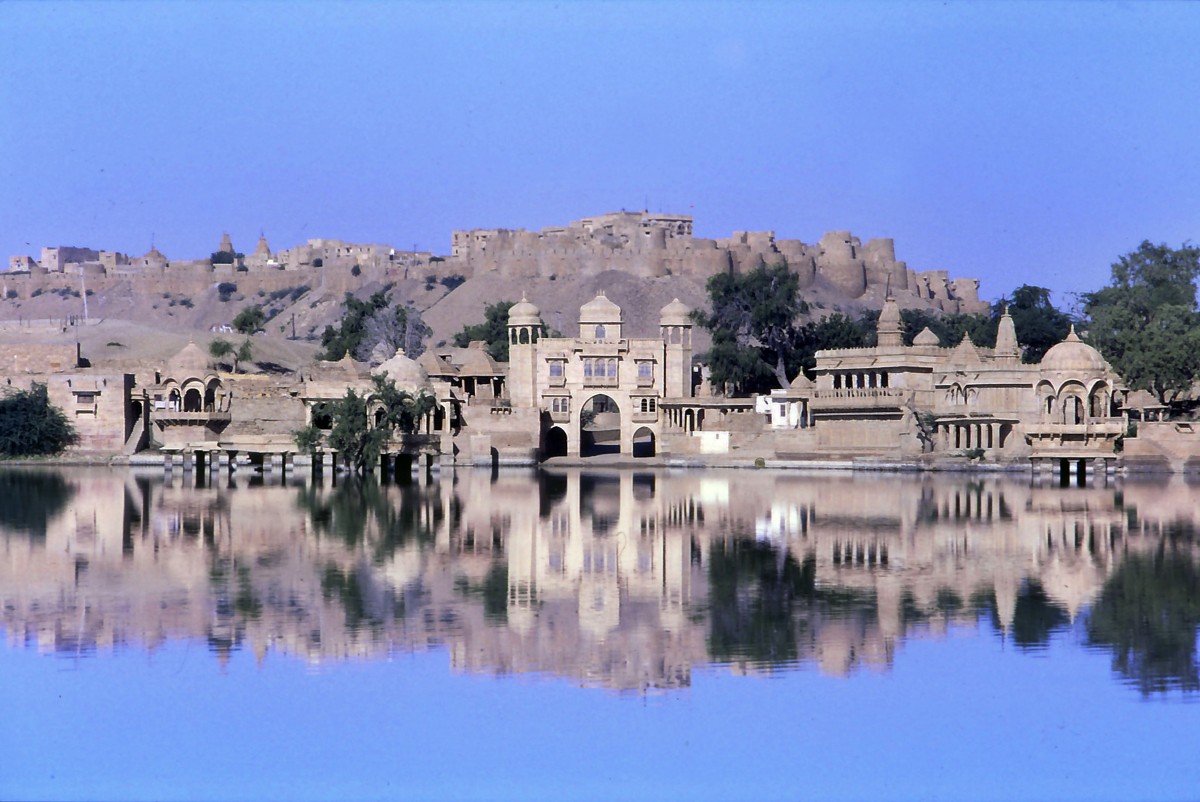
{"left": 4, "top": 211, "right": 986, "bottom": 321}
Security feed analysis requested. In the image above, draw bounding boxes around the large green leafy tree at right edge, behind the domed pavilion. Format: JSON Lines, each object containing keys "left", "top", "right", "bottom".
{"left": 1082, "top": 236, "right": 1200, "bottom": 405}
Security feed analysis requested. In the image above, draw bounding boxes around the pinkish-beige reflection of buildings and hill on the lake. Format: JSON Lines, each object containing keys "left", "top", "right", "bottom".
{"left": 0, "top": 469, "right": 1200, "bottom": 689}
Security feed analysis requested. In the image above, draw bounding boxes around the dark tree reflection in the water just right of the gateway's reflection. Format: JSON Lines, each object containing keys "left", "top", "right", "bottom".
{"left": 708, "top": 539, "right": 875, "bottom": 664}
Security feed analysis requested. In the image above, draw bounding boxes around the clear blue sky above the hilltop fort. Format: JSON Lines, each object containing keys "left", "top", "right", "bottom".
{"left": 0, "top": 2, "right": 1200, "bottom": 298}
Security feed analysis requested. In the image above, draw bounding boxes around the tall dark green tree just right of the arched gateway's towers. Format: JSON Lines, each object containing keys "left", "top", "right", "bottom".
{"left": 692, "top": 264, "right": 808, "bottom": 393}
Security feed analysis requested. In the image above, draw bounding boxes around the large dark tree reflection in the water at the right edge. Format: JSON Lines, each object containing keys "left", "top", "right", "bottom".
{"left": 1087, "top": 546, "right": 1200, "bottom": 694}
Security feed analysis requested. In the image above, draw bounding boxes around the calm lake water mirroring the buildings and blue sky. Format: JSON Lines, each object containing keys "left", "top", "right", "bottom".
{"left": 0, "top": 469, "right": 1200, "bottom": 800}
